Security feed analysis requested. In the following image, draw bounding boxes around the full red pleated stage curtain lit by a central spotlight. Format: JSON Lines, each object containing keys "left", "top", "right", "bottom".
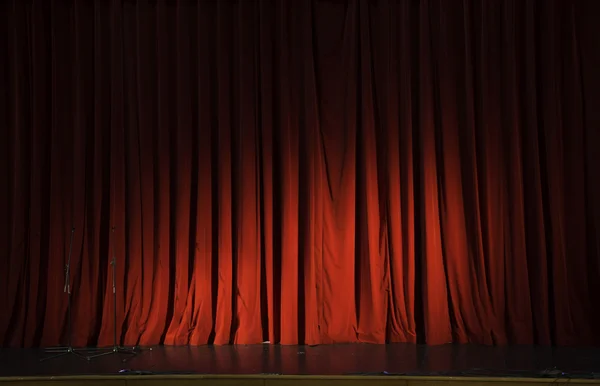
{"left": 0, "top": 0, "right": 600, "bottom": 347}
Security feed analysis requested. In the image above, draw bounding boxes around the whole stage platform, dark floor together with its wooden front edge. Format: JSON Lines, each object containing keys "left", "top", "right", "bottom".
{"left": 0, "top": 344, "right": 600, "bottom": 386}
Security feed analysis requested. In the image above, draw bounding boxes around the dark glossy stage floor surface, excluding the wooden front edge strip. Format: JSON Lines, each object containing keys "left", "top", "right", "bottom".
{"left": 0, "top": 344, "right": 600, "bottom": 379}
